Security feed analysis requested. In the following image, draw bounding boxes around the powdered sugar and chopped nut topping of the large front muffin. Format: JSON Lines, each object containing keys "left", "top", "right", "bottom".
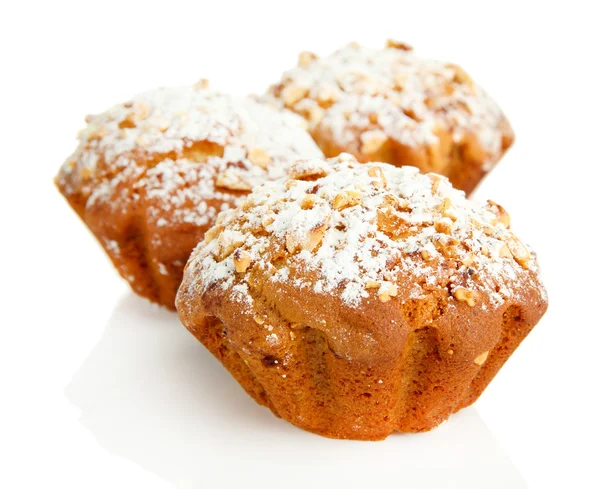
{"left": 187, "top": 154, "right": 544, "bottom": 310}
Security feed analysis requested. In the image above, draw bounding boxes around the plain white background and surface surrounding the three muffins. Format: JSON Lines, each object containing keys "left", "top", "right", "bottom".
{"left": 0, "top": 0, "right": 600, "bottom": 489}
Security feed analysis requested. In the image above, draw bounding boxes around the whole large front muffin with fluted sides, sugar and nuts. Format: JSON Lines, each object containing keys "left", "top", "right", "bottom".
{"left": 177, "top": 154, "right": 547, "bottom": 440}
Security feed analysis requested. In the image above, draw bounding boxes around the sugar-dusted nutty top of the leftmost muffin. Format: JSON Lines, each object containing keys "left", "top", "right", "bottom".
{"left": 57, "top": 81, "right": 322, "bottom": 225}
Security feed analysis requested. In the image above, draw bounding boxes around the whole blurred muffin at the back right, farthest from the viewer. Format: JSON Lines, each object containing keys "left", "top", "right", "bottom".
{"left": 266, "top": 41, "right": 514, "bottom": 194}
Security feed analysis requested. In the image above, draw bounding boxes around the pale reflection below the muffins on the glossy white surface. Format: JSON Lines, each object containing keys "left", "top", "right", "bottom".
{"left": 65, "top": 294, "right": 527, "bottom": 488}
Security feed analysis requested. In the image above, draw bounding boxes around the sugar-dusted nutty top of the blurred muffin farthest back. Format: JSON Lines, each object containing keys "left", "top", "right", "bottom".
{"left": 267, "top": 41, "right": 512, "bottom": 170}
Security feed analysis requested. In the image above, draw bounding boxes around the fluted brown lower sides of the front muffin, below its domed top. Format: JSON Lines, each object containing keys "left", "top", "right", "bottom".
{"left": 188, "top": 300, "right": 537, "bottom": 440}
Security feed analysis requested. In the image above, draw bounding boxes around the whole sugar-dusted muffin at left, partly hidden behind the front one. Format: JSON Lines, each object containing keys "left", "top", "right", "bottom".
{"left": 56, "top": 82, "right": 322, "bottom": 309}
